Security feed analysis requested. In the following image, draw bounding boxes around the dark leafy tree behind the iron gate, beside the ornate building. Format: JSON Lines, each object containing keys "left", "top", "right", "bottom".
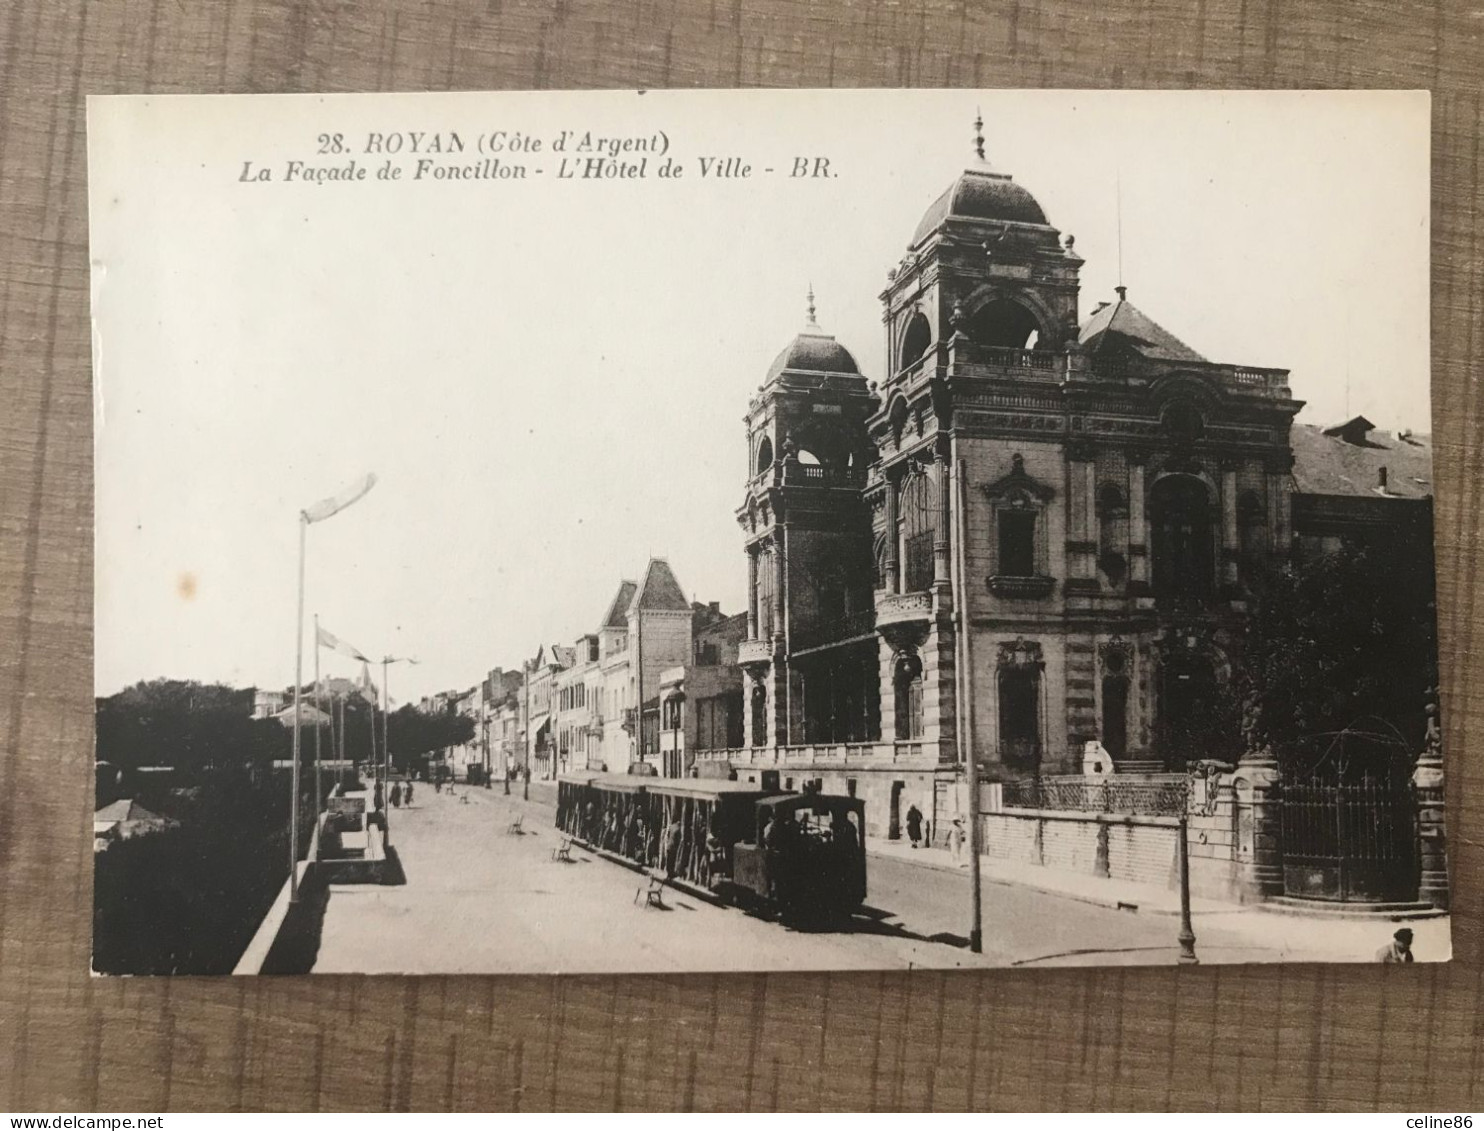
{"left": 1244, "top": 527, "right": 1438, "bottom": 767}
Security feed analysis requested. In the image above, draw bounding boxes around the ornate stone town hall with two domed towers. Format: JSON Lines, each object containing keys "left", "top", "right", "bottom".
{"left": 733, "top": 120, "right": 1301, "bottom": 833}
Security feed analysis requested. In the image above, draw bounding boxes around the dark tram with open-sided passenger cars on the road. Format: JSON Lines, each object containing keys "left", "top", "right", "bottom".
{"left": 557, "top": 773, "right": 865, "bottom": 919}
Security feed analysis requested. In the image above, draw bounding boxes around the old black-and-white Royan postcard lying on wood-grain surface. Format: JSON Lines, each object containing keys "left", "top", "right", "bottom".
{"left": 88, "top": 91, "right": 1451, "bottom": 975}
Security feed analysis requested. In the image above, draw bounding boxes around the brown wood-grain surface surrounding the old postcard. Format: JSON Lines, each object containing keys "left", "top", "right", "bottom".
{"left": 0, "top": 0, "right": 1484, "bottom": 1113}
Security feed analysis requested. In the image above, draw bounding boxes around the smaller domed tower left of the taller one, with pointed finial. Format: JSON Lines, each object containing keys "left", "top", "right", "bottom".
{"left": 738, "top": 289, "right": 877, "bottom": 747}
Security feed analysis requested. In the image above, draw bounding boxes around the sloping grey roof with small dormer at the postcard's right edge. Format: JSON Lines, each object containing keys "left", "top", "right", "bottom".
{"left": 1288, "top": 424, "right": 1432, "bottom": 499}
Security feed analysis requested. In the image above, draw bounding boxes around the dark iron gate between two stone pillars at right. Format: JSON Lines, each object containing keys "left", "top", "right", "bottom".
{"left": 1282, "top": 773, "right": 1419, "bottom": 902}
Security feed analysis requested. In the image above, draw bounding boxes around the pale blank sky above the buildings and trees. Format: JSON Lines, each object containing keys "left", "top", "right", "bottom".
{"left": 89, "top": 91, "right": 1431, "bottom": 701}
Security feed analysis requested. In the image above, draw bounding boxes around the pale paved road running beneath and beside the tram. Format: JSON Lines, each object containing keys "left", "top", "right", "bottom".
{"left": 315, "top": 787, "right": 1294, "bottom": 974}
